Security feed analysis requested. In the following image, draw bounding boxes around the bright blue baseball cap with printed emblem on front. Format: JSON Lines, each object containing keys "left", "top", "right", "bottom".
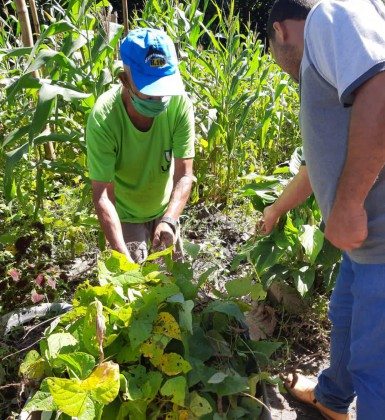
{"left": 120, "top": 28, "right": 185, "bottom": 96}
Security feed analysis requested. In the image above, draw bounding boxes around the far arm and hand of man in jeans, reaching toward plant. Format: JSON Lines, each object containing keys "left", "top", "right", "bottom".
{"left": 256, "top": 165, "right": 313, "bottom": 235}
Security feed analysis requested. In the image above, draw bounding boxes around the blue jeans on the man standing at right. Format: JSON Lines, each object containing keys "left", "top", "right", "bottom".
{"left": 315, "top": 254, "right": 385, "bottom": 420}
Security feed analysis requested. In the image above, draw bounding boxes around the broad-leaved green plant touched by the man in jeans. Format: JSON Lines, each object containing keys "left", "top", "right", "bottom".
{"left": 233, "top": 151, "right": 341, "bottom": 296}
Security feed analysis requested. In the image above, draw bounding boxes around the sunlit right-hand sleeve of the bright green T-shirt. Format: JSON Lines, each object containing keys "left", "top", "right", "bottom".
{"left": 173, "top": 96, "right": 195, "bottom": 159}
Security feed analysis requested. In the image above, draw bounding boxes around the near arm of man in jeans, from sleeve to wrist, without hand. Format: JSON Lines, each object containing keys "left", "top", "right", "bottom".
{"left": 335, "top": 72, "right": 385, "bottom": 208}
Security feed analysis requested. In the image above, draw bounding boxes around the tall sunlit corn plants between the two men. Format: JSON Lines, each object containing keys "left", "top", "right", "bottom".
{"left": 137, "top": 0, "right": 299, "bottom": 201}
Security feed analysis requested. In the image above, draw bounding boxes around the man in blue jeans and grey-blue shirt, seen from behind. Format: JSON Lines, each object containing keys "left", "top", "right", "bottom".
{"left": 268, "top": 0, "right": 385, "bottom": 420}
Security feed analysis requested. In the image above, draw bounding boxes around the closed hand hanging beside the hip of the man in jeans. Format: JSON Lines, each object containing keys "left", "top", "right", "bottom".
{"left": 325, "top": 203, "right": 368, "bottom": 251}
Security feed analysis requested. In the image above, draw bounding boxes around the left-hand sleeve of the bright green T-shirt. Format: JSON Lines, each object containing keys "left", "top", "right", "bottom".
{"left": 86, "top": 112, "right": 116, "bottom": 182}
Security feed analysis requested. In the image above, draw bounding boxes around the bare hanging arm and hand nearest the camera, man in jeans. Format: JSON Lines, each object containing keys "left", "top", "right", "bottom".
{"left": 325, "top": 71, "right": 385, "bottom": 251}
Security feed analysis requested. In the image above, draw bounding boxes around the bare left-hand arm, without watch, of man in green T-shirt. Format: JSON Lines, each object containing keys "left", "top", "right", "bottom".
{"left": 92, "top": 181, "right": 132, "bottom": 261}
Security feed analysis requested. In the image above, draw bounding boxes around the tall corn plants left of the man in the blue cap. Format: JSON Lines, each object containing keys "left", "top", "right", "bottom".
{"left": 1, "top": 0, "right": 122, "bottom": 218}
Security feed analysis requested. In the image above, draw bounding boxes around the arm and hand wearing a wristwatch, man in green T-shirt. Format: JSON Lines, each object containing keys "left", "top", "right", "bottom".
{"left": 153, "top": 158, "right": 194, "bottom": 249}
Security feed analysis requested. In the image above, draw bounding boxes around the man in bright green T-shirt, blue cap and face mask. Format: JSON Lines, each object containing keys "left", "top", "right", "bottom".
{"left": 86, "top": 28, "right": 195, "bottom": 263}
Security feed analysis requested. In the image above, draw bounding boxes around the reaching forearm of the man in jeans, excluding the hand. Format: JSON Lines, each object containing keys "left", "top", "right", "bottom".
{"left": 272, "top": 166, "right": 313, "bottom": 215}
